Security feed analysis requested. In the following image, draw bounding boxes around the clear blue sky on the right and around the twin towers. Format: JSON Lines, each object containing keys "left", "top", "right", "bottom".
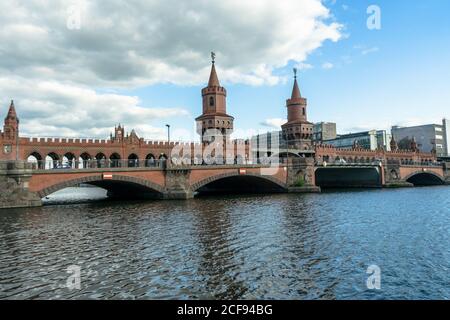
{"left": 118, "top": 0, "right": 450, "bottom": 140}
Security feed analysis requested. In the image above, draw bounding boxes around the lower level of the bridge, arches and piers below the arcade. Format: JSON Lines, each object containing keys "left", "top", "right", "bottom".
{"left": 0, "top": 152, "right": 450, "bottom": 208}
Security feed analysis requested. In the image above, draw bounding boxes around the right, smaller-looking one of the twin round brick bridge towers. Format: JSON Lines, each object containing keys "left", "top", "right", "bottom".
{"left": 281, "top": 69, "right": 313, "bottom": 151}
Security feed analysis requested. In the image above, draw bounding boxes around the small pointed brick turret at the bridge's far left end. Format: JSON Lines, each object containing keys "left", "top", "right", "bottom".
{"left": 1, "top": 100, "right": 19, "bottom": 160}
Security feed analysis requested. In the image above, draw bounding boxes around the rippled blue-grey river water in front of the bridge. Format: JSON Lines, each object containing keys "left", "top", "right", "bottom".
{"left": 0, "top": 187, "right": 450, "bottom": 299}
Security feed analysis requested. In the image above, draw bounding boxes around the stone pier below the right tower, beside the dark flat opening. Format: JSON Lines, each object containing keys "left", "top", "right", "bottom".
{"left": 286, "top": 158, "right": 320, "bottom": 193}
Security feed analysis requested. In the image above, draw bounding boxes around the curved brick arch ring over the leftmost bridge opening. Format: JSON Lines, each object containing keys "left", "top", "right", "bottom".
{"left": 37, "top": 175, "right": 164, "bottom": 198}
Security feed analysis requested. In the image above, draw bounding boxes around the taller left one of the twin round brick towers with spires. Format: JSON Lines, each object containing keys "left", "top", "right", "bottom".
{"left": 195, "top": 52, "right": 234, "bottom": 145}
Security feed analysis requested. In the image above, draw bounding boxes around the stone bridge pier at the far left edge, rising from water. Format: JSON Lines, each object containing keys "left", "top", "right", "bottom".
{"left": 0, "top": 161, "right": 42, "bottom": 209}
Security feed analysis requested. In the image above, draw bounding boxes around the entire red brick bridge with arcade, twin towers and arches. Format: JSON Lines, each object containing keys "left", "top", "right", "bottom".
{"left": 0, "top": 57, "right": 450, "bottom": 208}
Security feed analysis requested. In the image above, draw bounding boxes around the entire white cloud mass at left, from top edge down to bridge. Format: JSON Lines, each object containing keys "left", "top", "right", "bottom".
{"left": 0, "top": 0, "right": 342, "bottom": 138}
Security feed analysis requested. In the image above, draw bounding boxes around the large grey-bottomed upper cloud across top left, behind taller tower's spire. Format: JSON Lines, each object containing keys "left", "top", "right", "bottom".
{"left": 0, "top": 0, "right": 341, "bottom": 86}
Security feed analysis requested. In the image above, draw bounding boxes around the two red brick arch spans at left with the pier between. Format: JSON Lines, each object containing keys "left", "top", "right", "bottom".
{"left": 29, "top": 164, "right": 287, "bottom": 199}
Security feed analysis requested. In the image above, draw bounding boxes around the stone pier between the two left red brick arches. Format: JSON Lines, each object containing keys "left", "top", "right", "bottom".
{"left": 163, "top": 167, "right": 194, "bottom": 200}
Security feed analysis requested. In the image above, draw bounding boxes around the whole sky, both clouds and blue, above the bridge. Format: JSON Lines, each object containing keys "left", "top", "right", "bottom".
{"left": 0, "top": 0, "right": 450, "bottom": 140}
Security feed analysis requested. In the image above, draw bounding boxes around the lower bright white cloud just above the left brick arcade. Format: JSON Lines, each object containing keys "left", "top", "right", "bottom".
{"left": 0, "top": 77, "right": 189, "bottom": 139}
